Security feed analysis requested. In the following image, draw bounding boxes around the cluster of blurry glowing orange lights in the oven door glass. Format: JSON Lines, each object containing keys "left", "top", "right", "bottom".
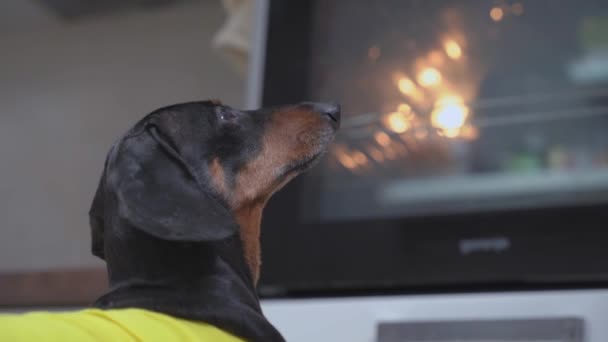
{"left": 332, "top": 21, "right": 490, "bottom": 174}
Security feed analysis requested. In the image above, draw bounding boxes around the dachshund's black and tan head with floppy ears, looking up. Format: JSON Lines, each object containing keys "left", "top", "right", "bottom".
{"left": 90, "top": 101, "right": 340, "bottom": 281}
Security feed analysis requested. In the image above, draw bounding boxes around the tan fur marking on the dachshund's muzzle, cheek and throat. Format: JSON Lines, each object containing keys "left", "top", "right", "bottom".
{"left": 210, "top": 109, "right": 332, "bottom": 283}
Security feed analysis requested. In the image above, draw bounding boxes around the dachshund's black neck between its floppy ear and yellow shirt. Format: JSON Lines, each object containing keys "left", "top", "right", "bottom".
{"left": 95, "top": 226, "right": 283, "bottom": 341}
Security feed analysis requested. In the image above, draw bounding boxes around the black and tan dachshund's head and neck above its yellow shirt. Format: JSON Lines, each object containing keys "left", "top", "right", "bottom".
{"left": 0, "top": 101, "right": 340, "bottom": 341}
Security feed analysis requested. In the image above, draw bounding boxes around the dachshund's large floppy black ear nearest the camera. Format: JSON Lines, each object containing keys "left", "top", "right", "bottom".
{"left": 106, "top": 123, "right": 238, "bottom": 241}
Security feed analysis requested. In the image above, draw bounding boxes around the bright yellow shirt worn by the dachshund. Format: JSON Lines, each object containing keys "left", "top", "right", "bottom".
{"left": 0, "top": 309, "right": 244, "bottom": 342}
